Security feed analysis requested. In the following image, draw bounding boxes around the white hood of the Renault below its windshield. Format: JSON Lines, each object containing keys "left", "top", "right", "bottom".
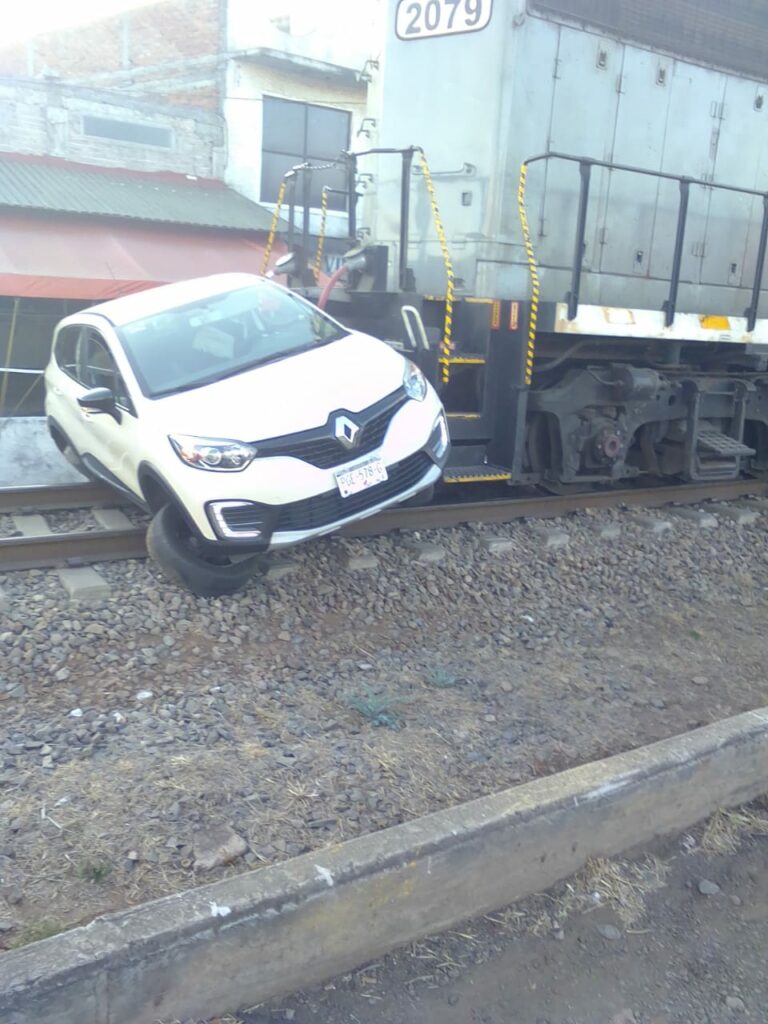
{"left": 152, "top": 332, "right": 411, "bottom": 441}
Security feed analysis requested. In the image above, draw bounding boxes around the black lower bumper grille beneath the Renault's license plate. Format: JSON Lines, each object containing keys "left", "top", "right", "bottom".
{"left": 274, "top": 452, "right": 434, "bottom": 532}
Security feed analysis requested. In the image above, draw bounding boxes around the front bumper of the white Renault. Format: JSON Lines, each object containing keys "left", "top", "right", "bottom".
{"left": 177, "top": 392, "right": 449, "bottom": 553}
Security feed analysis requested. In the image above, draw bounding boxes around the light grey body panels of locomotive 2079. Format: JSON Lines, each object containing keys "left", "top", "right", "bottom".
{"left": 359, "top": 0, "right": 768, "bottom": 314}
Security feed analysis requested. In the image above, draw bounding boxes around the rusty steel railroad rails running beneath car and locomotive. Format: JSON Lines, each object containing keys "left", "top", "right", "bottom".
{"left": 0, "top": 480, "right": 768, "bottom": 571}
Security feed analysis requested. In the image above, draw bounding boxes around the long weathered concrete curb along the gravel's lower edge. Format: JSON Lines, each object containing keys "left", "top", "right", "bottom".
{"left": 0, "top": 708, "right": 768, "bottom": 1024}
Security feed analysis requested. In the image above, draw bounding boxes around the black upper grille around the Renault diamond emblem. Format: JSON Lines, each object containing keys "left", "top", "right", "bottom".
{"left": 253, "top": 388, "right": 409, "bottom": 469}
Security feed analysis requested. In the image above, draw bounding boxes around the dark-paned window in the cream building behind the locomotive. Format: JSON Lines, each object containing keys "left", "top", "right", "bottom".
{"left": 261, "top": 96, "right": 351, "bottom": 210}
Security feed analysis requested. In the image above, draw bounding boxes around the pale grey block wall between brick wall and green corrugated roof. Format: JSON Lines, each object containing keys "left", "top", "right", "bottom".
{"left": 0, "top": 78, "right": 226, "bottom": 178}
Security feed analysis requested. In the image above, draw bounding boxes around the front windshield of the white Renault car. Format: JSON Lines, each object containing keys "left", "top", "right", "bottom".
{"left": 119, "top": 282, "right": 348, "bottom": 398}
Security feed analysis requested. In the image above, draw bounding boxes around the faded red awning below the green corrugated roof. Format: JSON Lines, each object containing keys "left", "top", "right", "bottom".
{"left": 0, "top": 211, "right": 283, "bottom": 301}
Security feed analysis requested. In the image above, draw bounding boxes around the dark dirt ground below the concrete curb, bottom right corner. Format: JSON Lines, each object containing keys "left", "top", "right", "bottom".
{"left": 250, "top": 812, "right": 768, "bottom": 1024}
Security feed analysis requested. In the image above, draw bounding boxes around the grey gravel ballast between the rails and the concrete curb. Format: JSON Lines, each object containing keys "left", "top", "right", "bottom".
{"left": 0, "top": 511, "right": 768, "bottom": 948}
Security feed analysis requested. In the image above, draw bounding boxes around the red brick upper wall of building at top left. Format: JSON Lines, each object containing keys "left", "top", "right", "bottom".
{"left": 0, "top": 0, "right": 225, "bottom": 111}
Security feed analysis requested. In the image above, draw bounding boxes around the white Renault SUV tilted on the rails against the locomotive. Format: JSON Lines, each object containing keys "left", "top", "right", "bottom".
{"left": 45, "top": 273, "right": 449, "bottom": 595}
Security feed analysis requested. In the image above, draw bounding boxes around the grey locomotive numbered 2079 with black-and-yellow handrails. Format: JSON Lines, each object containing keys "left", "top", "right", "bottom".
{"left": 278, "top": 0, "right": 768, "bottom": 490}
